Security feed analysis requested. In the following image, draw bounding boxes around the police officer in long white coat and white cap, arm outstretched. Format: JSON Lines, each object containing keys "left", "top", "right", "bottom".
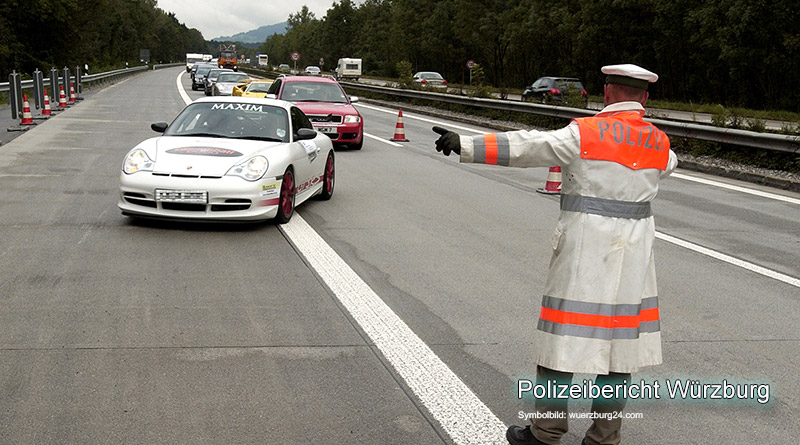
{"left": 434, "top": 64, "right": 678, "bottom": 445}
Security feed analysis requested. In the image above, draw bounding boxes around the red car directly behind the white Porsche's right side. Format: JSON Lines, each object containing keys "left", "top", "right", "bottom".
{"left": 267, "top": 76, "right": 364, "bottom": 150}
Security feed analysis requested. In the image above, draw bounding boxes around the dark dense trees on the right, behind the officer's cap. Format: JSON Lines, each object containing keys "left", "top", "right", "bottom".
{"left": 259, "top": 0, "right": 800, "bottom": 111}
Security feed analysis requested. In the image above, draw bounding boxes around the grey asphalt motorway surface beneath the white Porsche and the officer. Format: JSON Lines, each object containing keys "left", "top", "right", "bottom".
{"left": 0, "top": 69, "right": 800, "bottom": 444}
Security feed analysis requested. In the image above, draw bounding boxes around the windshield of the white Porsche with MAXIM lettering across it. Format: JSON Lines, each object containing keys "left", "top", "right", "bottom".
{"left": 164, "top": 102, "right": 289, "bottom": 142}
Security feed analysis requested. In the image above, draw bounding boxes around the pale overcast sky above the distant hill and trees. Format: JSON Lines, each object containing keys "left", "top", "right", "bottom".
{"left": 158, "top": 0, "right": 334, "bottom": 40}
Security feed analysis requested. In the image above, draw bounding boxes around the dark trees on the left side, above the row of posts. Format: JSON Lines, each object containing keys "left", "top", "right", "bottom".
{"left": 0, "top": 0, "right": 207, "bottom": 77}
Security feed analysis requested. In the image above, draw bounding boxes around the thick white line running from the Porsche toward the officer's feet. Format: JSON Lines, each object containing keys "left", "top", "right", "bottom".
{"left": 279, "top": 213, "right": 506, "bottom": 444}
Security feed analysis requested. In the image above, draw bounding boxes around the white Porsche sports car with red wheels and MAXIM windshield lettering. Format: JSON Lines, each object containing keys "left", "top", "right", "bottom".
{"left": 118, "top": 96, "right": 334, "bottom": 223}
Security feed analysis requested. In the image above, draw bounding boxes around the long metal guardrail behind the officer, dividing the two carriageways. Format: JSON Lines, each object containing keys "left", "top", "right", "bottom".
{"left": 340, "top": 82, "right": 800, "bottom": 153}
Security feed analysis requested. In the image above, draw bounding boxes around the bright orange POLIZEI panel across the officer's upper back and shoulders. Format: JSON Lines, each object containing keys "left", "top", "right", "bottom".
{"left": 574, "top": 111, "right": 669, "bottom": 170}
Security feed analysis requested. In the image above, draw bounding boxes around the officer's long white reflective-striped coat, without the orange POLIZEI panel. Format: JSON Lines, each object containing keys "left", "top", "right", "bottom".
{"left": 460, "top": 102, "right": 678, "bottom": 374}
